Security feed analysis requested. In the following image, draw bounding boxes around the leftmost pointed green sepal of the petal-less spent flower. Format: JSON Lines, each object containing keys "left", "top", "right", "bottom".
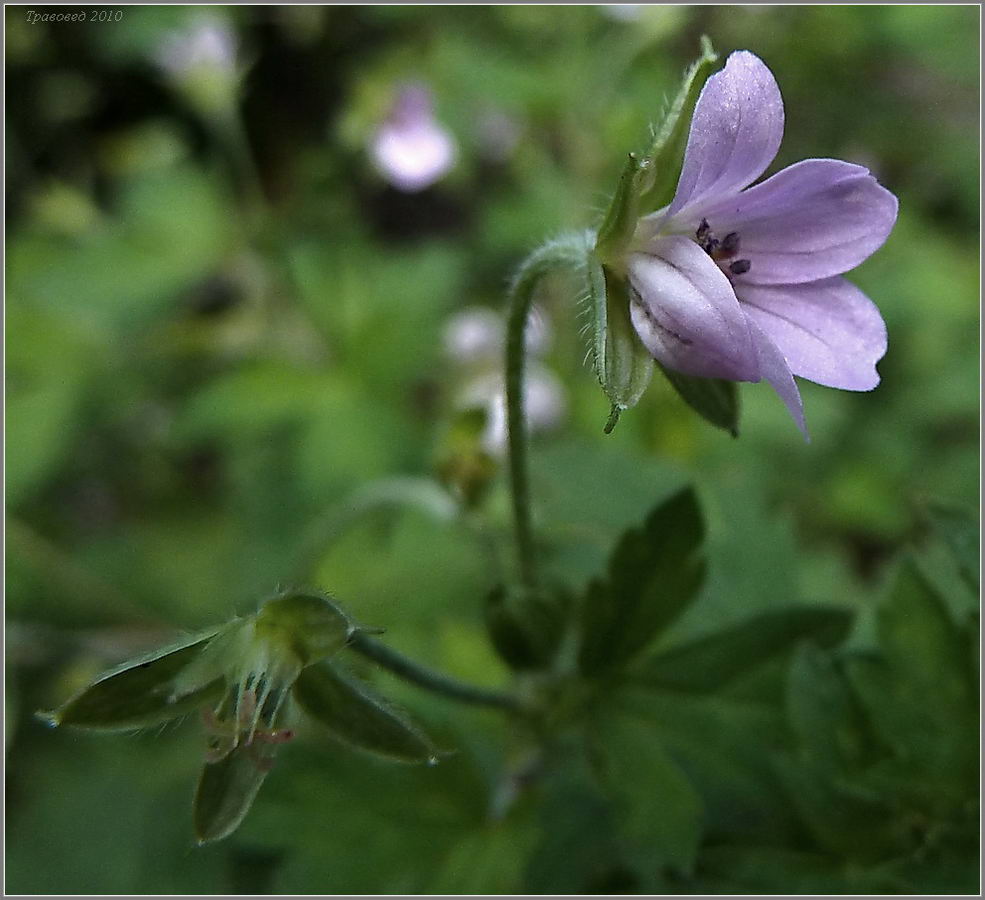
{"left": 38, "top": 629, "right": 223, "bottom": 731}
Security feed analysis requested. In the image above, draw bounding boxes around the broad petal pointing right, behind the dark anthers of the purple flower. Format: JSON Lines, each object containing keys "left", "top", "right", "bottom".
{"left": 702, "top": 159, "right": 898, "bottom": 284}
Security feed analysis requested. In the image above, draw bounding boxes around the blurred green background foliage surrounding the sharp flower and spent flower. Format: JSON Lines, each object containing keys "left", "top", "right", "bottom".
{"left": 5, "top": 6, "right": 979, "bottom": 893}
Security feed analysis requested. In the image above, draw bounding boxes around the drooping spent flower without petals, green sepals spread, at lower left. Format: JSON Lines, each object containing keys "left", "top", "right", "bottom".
{"left": 41, "top": 591, "right": 437, "bottom": 843}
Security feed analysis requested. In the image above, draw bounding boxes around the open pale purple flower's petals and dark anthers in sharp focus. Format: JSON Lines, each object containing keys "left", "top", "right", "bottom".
{"left": 626, "top": 51, "right": 897, "bottom": 436}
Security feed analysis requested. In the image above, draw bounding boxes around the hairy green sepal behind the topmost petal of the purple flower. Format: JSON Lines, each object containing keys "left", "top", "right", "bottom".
{"left": 636, "top": 35, "right": 718, "bottom": 215}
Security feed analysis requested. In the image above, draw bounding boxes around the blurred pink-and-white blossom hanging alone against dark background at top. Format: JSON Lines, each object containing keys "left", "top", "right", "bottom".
{"left": 370, "top": 84, "right": 456, "bottom": 193}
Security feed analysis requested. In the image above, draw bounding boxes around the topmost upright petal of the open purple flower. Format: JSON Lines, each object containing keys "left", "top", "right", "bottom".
{"left": 667, "top": 50, "right": 783, "bottom": 216}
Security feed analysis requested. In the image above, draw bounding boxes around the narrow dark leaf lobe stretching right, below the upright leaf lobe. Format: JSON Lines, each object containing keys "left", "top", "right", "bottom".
{"left": 633, "top": 606, "right": 853, "bottom": 693}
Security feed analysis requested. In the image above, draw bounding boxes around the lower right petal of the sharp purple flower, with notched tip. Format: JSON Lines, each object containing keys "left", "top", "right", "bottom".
{"left": 736, "top": 277, "right": 886, "bottom": 391}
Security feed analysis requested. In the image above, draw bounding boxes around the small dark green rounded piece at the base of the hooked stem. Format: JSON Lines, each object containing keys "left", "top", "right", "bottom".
{"left": 485, "top": 586, "right": 571, "bottom": 670}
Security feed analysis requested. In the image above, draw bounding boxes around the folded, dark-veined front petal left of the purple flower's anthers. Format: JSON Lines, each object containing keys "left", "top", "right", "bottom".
{"left": 628, "top": 236, "right": 759, "bottom": 381}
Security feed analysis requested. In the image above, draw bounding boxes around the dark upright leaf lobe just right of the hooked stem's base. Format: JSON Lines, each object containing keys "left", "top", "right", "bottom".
{"left": 578, "top": 488, "right": 705, "bottom": 675}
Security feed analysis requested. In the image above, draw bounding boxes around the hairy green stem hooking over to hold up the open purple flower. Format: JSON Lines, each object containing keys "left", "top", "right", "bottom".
{"left": 506, "top": 234, "right": 589, "bottom": 589}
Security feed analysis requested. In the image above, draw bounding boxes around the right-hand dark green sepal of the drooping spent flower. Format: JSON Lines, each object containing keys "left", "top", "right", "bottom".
{"left": 293, "top": 661, "right": 438, "bottom": 764}
